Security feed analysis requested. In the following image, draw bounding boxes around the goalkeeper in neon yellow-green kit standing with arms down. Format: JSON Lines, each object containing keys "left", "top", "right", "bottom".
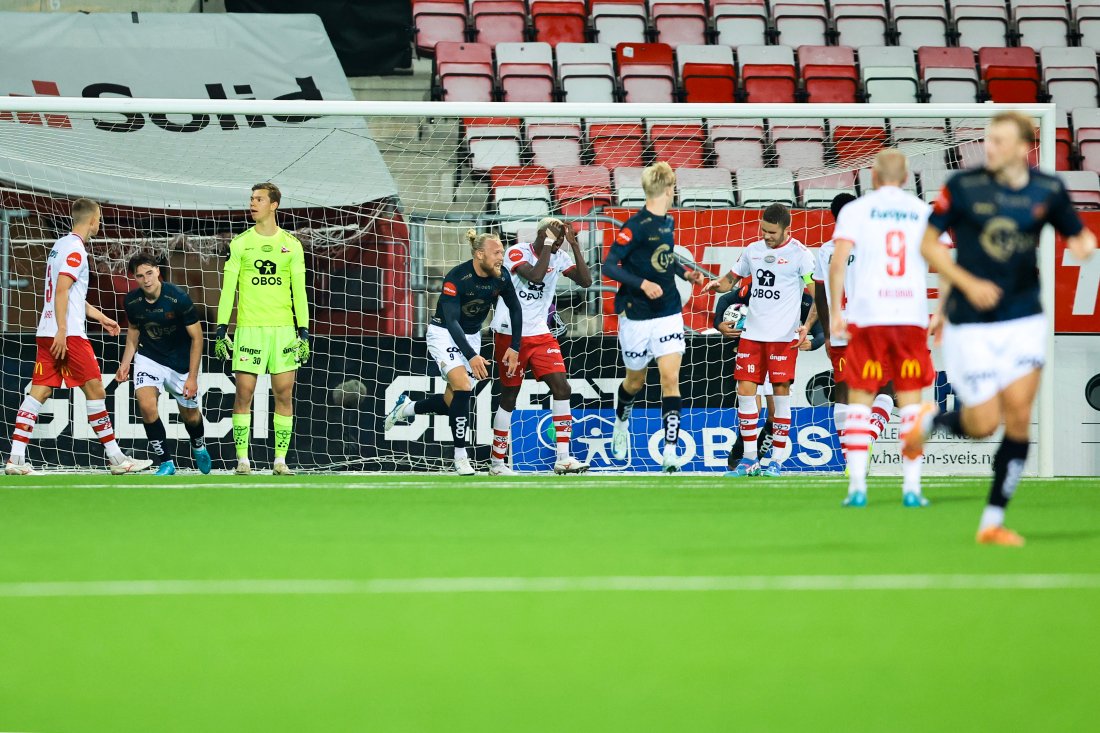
{"left": 215, "top": 183, "right": 309, "bottom": 475}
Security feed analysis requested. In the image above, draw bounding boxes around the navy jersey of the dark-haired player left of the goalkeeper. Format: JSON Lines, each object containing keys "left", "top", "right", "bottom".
{"left": 127, "top": 283, "right": 199, "bottom": 374}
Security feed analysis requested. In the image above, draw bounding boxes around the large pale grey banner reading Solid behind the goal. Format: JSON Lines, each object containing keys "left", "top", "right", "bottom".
{"left": 0, "top": 13, "right": 397, "bottom": 211}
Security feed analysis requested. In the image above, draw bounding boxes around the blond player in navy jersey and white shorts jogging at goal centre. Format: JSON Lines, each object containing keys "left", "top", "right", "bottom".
{"left": 604, "top": 162, "right": 705, "bottom": 471}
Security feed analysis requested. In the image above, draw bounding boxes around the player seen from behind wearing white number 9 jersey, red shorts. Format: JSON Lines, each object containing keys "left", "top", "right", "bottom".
{"left": 829, "top": 150, "right": 935, "bottom": 506}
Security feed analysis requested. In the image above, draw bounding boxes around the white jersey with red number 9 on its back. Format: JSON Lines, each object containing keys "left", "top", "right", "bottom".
{"left": 833, "top": 186, "right": 932, "bottom": 326}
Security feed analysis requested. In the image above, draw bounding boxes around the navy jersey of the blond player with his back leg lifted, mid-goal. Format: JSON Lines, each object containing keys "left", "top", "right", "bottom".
{"left": 604, "top": 209, "right": 684, "bottom": 320}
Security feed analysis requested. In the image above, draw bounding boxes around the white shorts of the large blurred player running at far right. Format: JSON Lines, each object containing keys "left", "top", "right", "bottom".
{"left": 943, "top": 314, "right": 1047, "bottom": 405}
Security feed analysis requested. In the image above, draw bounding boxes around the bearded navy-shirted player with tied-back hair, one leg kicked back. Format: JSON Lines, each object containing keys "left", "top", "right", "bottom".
{"left": 385, "top": 229, "right": 524, "bottom": 475}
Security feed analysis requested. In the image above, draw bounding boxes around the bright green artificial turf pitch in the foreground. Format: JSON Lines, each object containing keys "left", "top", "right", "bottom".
{"left": 0, "top": 474, "right": 1100, "bottom": 733}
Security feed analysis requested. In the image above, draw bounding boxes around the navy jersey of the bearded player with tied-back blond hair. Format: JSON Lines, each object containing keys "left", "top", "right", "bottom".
{"left": 431, "top": 260, "right": 524, "bottom": 359}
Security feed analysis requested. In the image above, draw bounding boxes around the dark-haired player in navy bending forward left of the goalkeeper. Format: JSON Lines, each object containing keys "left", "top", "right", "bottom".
{"left": 114, "top": 253, "right": 210, "bottom": 475}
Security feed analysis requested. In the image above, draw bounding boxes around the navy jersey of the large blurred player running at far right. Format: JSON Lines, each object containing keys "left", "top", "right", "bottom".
{"left": 928, "top": 168, "right": 1084, "bottom": 324}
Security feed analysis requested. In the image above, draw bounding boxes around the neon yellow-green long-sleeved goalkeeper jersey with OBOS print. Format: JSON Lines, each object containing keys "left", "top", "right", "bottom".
{"left": 218, "top": 227, "right": 309, "bottom": 328}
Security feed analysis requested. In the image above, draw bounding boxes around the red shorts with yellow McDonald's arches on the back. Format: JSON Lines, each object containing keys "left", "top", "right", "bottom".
{"left": 845, "top": 326, "right": 936, "bottom": 393}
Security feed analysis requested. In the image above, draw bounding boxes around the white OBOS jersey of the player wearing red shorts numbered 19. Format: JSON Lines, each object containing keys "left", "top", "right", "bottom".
{"left": 734, "top": 238, "right": 814, "bottom": 343}
